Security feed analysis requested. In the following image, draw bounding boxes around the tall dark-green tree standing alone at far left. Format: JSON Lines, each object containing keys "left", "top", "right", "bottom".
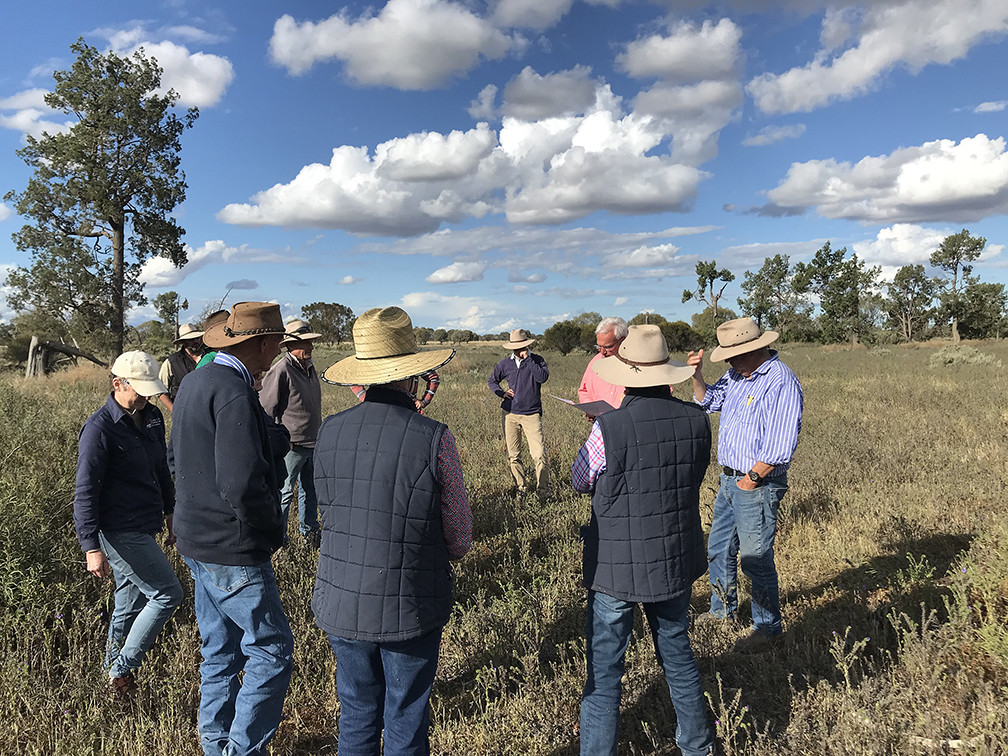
{"left": 4, "top": 38, "right": 199, "bottom": 355}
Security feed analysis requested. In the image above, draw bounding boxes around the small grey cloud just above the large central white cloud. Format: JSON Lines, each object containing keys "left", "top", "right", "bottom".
{"left": 501, "top": 66, "right": 596, "bottom": 121}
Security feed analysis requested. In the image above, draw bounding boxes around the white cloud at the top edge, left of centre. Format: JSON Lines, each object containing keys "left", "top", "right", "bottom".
{"left": 269, "top": 0, "right": 511, "bottom": 90}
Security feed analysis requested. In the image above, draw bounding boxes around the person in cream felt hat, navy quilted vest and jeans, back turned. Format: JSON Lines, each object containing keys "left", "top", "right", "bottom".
{"left": 571, "top": 326, "right": 714, "bottom": 756}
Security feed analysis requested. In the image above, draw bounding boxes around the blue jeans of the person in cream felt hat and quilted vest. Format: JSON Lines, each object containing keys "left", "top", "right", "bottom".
{"left": 580, "top": 591, "right": 714, "bottom": 756}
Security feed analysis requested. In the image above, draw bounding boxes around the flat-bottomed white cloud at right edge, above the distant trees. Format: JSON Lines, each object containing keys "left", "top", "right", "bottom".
{"left": 767, "top": 134, "right": 1008, "bottom": 223}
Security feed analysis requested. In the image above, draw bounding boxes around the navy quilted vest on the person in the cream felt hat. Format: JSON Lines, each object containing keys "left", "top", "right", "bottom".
{"left": 582, "top": 387, "right": 711, "bottom": 603}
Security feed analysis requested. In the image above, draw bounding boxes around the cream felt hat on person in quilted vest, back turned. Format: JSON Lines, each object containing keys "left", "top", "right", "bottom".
{"left": 592, "top": 326, "right": 695, "bottom": 388}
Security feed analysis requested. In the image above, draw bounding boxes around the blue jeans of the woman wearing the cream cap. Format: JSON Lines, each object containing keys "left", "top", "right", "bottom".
{"left": 98, "top": 530, "right": 182, "bottom": 677}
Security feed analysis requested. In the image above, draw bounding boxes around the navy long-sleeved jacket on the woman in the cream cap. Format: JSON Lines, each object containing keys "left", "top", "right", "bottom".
{"left": 74, "top": 394, "right": 175, "bottom": 551}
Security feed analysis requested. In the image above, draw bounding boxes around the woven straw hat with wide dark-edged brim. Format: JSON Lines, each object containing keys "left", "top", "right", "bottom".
{"left": 322, "top": 307, "right": 455, "bottom": 386}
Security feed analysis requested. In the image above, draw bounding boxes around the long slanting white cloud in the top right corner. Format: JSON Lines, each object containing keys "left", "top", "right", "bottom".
{"left": 748, "top": 0, "right": 1008, "bottom": 113}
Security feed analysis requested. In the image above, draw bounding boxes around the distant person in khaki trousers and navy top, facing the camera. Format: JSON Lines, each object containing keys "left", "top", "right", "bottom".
{"left": 487, "top": 329, "right": 549, "bottom": 497}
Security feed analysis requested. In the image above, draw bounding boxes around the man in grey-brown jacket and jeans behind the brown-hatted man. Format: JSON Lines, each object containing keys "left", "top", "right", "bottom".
{"left": 259, "top": 321, "right": 322, "bottom": 548}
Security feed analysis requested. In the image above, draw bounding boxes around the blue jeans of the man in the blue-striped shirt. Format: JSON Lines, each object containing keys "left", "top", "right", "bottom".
{"left": 707, "top": 474, "right": 787, "bottom": 635}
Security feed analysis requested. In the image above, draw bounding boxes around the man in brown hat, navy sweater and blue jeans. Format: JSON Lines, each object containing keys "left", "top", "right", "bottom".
{"left": 168, "top": 302, "right": 294, "bottom": 756}
